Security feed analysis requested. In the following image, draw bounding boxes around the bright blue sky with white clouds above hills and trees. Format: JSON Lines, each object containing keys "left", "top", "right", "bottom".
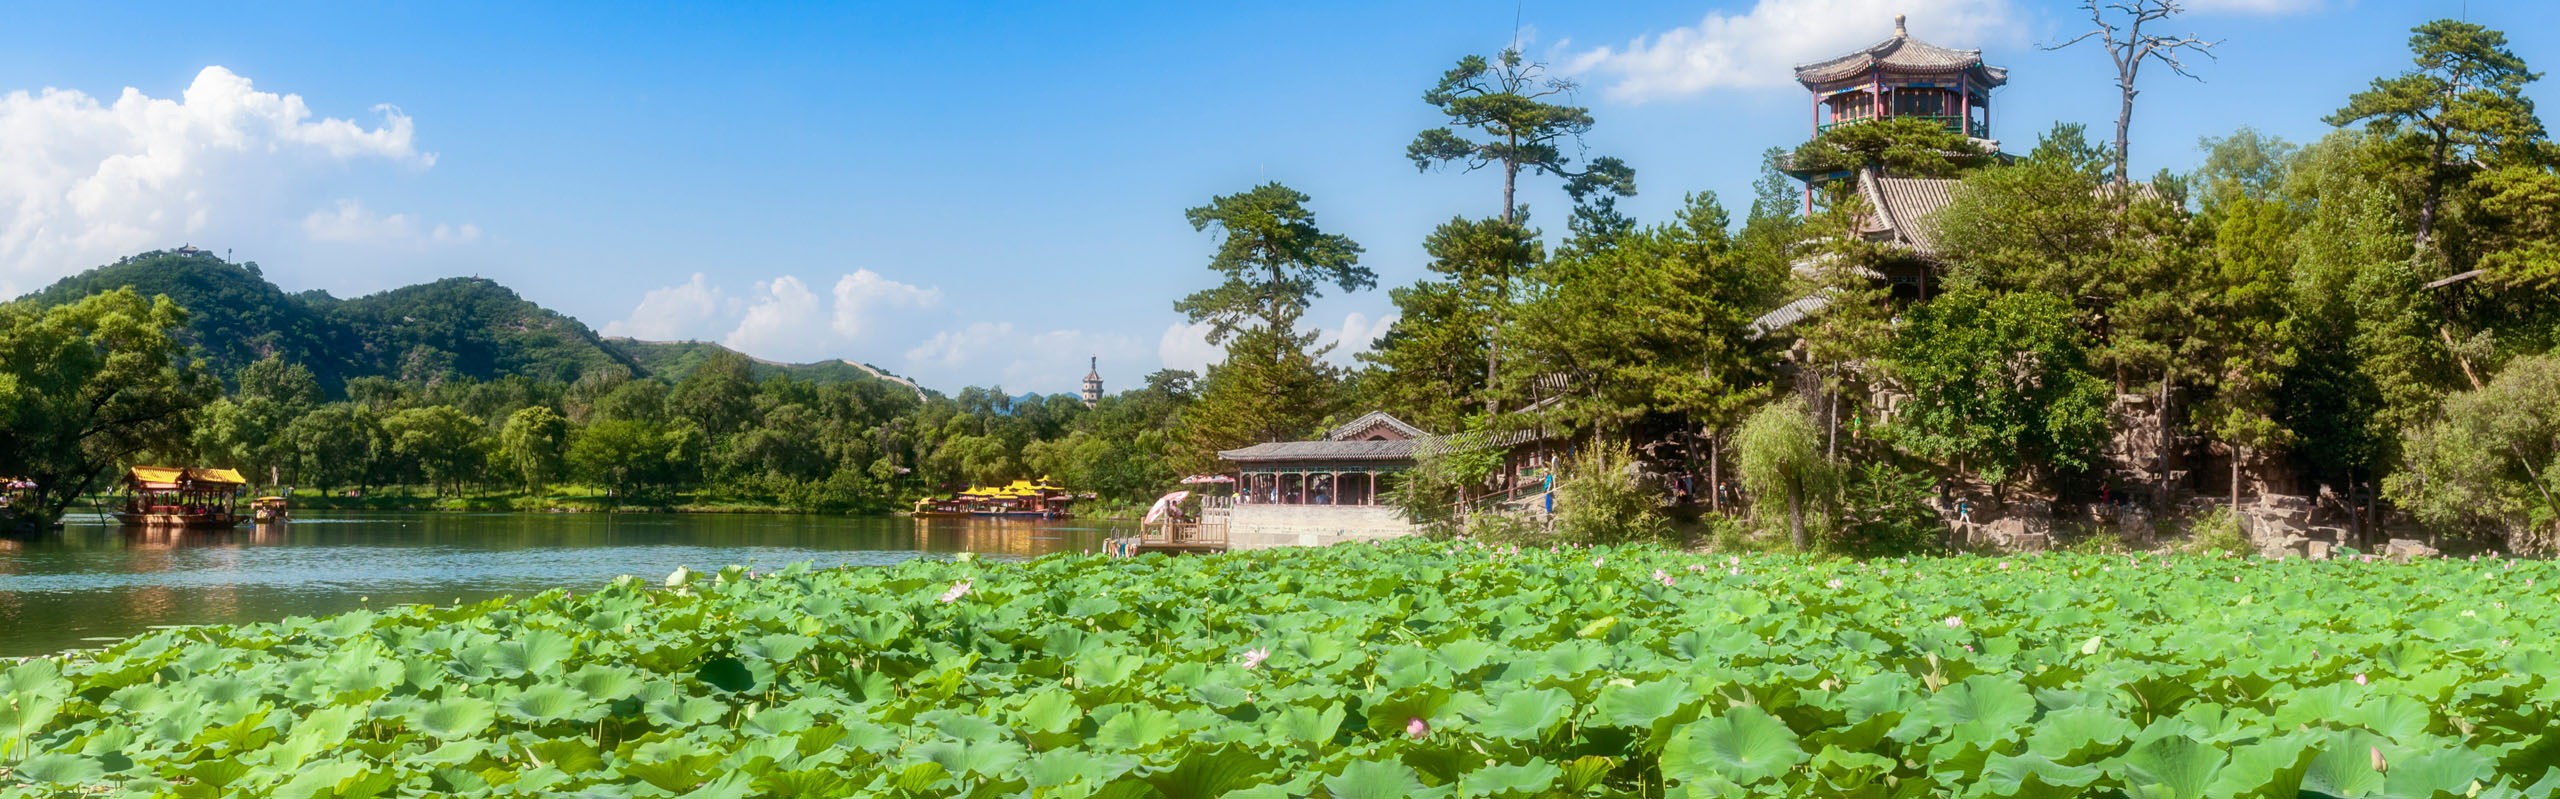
{"left": 0, "top": 0, "right": 2529, "bottom": 392}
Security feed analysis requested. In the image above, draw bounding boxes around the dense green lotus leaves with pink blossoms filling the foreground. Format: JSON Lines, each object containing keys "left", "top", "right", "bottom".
{"left": 0, "top": 540, "right": 2560, "bottom": 796}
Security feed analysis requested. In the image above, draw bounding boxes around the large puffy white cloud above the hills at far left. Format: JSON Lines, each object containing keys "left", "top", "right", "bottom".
{"left": 0, "top": 67, "right": 435, "bottom": 297}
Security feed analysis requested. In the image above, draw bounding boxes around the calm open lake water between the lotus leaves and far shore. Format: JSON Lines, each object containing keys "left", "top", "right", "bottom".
{"left": 0, "top": 512, "right": 1111, "bottom": 656}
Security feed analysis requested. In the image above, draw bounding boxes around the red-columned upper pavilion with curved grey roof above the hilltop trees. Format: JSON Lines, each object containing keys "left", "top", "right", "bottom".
{"left": 1789, "top": 15, "right": 2010, "bottom": 210}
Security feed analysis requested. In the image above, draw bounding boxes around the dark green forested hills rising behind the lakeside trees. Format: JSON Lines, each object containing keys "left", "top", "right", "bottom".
{"left": 20, "top": 248, "right": 922, "bottom": 397}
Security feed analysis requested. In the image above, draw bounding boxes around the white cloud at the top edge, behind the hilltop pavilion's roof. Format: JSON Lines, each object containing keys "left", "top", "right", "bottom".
{"left": 1562, "top": 0, "right": 2017, "bottom": 102}
